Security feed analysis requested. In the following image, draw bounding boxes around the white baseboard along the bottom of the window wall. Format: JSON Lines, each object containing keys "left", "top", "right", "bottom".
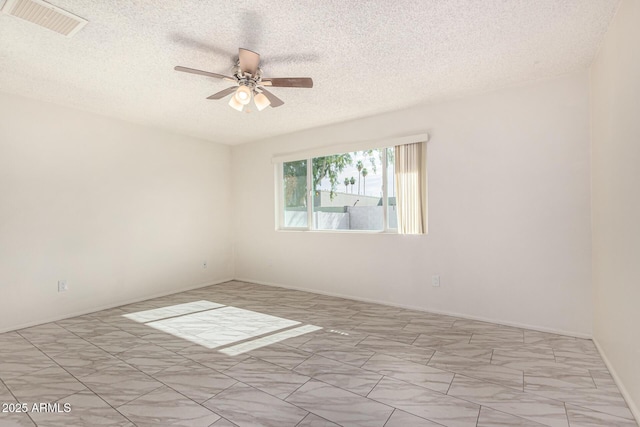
{"left": 238, "top": 278, "right": 592, "bottom": 339}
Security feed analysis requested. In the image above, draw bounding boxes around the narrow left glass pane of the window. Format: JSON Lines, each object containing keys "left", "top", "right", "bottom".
{"left": 282, "top": 160, "right": 307, "bottom": 227}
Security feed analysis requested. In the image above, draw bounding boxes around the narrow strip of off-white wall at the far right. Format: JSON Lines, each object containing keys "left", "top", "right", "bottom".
{"left": 591, "top": 0, "right": 640, "bottom": 420}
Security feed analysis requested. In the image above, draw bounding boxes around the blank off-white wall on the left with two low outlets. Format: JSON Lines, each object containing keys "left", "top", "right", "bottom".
{"left": 0, "top": 94, "right": 233, "bottom": 332}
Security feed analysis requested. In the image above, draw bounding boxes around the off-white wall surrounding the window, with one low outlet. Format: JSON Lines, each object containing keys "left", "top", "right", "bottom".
{"left": 232, "top": 72, "right": 592, "bottom": 336}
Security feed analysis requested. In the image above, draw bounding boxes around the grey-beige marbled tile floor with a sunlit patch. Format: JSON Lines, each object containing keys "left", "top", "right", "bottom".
{"left": 0, "top": 282, "right": 636, "bottom": 427}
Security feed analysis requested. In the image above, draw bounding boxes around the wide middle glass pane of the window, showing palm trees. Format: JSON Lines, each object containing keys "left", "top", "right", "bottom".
{"left": 312, "top": 149, "right": 384, "bottom": 230}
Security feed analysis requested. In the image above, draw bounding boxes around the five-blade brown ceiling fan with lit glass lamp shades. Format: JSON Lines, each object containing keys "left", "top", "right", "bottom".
{"left": 174, "top": 48, "right": 313, "bottom": 111}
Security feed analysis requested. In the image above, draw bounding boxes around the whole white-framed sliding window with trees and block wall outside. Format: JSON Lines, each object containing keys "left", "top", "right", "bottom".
{"left": 277, "top": 141, "right": 425, "bottom": 234}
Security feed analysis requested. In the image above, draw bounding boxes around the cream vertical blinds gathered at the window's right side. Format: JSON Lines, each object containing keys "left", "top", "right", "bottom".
{"left": 394, "top": 142, "right": 427, "bottom": 234}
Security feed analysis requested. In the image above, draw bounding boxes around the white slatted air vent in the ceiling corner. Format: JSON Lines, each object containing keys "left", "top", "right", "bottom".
{"left": 2, "top": 0, "right": 87, "bottom": 37}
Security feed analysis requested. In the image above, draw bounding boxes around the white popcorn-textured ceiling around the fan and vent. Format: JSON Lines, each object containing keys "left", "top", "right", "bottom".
{"left": 0, "top": 0, "right": 618, "bottom": 144}
